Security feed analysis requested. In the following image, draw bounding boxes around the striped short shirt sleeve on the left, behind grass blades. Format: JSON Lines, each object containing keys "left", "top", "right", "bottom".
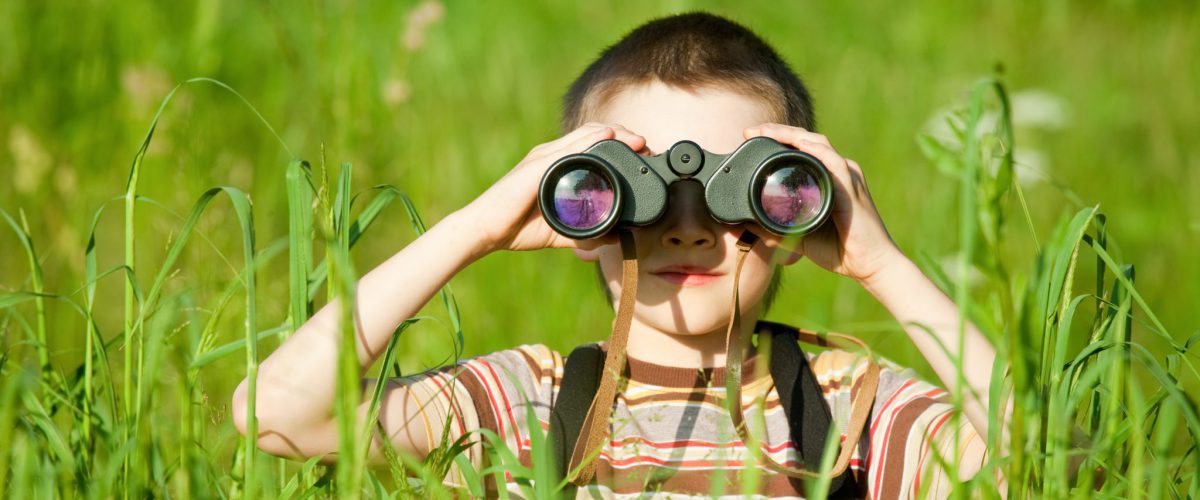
{"left": 400, "top": 344, "right": 563, "bottom": 482}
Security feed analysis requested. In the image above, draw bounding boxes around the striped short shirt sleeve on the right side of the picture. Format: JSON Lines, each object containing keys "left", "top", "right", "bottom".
{"left": 864, "top": 360, "right": 986, "bottom": 499}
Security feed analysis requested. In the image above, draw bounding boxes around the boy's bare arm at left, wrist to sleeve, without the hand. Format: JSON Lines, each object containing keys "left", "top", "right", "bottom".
{"left": 233, "top": 213, "right": 482, "bottom": 457}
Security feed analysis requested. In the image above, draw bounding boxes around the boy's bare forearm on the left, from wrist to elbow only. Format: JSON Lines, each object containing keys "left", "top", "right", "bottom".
{"left": 235, "top": 209, "right": 484, "bottom": 430}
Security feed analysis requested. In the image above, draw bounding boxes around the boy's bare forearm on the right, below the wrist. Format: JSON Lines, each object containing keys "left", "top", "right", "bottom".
{"left": 863, "top": 251, "right": 996, "bottom": 436}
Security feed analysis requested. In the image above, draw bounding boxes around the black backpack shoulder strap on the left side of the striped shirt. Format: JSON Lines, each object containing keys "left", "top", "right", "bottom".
{"left": 550, "top": 343, "right": 605, "bottom": 481}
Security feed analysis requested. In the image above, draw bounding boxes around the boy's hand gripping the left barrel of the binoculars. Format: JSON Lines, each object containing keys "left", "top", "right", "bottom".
{"left": 458, "top": 124, "right": 646, "bottom": 257}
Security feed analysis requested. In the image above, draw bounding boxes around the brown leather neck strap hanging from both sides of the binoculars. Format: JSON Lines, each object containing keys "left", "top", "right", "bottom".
{"left": 566, "top": 229, "right": 880, "bottom": 486}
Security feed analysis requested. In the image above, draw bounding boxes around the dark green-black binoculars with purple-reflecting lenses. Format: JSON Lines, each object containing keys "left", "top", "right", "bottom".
{"left": 538, "top": 137, "right": 833, "bottom": 240}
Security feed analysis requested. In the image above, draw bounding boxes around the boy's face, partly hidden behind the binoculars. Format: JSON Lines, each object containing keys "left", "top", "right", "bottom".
{"left": 576, "top": 82, "right": 798, "bottom": 335}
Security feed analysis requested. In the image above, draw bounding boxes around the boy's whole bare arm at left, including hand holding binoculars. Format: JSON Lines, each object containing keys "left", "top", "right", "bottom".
{"left": 233, "top": 124, "right": 644, "bottom": 457}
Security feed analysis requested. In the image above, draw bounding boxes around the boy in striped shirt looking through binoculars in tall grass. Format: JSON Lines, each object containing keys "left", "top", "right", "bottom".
{"left": 233, "top": 13, "right": 995, "bottom": 498}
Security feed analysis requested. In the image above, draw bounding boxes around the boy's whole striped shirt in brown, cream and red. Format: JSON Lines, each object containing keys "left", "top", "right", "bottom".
{"left": 403, "top": 328, "right": 985, "bottom": 499}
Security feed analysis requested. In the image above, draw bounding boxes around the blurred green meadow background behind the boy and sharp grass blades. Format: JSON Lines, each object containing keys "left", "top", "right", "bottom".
{"left": 0, "top": 0, "right": 1200, "bottom": 386}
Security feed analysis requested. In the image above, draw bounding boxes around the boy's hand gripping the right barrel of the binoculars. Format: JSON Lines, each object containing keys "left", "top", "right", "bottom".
{"left": 743, "top": 124, "right": 904, "bottom": 282}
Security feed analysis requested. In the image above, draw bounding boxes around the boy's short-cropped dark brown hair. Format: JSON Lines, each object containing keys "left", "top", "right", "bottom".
{"left": 562, "top": 12, "right": 816, "bottom": 313}
